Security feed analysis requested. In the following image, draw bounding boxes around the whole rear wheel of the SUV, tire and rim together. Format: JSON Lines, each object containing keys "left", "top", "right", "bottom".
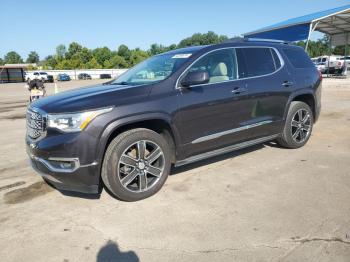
{"left": 277, "top": 101, "right": 314, "bottom": 149}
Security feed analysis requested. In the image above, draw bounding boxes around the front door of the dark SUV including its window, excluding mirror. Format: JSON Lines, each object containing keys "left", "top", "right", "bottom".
{"left": 178, "top": 48, "right": 253, "bottom": 156}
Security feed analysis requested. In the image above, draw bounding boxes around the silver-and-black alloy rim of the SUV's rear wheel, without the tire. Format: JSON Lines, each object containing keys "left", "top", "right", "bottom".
{"left": 291, "top": 109, "right": 311, "bottom": 143}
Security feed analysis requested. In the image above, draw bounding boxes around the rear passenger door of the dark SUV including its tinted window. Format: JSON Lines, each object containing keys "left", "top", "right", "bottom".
{"left": 236, "top": 46, "right": 294, "bottom": 139}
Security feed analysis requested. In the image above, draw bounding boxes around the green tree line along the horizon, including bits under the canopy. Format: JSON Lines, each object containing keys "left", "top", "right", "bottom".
{"left": 0, "top": 31, "right": 350, "bottom": 69}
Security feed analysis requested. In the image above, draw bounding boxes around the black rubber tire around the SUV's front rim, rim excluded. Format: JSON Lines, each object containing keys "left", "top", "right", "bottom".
{"left": 102, "top": 129, "right": 171, "bottom": 201}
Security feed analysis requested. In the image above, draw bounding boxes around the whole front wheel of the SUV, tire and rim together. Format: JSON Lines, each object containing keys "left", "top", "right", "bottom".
{"left": 101, "top": 128, "right": 171, "bottom": 201}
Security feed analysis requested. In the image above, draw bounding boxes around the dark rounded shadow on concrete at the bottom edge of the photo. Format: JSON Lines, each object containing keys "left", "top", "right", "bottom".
{"left": 96, "top": 240, "right": 140, "bottom": 262}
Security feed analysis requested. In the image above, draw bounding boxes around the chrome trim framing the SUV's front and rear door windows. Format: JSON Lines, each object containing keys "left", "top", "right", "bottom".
{"left": 175, "top": 46, "right": 285, "bottom": 90}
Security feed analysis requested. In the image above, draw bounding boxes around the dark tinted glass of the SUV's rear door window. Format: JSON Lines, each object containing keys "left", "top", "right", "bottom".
{"left": 237, "top": 48, "right": 281, "bottom": 78}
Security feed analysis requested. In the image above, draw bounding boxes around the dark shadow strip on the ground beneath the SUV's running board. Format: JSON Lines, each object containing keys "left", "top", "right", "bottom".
{"left": 170, "top": 143, "right": 266, "bottom": 176}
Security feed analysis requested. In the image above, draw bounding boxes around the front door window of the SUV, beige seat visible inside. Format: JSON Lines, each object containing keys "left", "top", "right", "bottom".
{"left": 189, "top": 48, "right": 237, "bottom": 83}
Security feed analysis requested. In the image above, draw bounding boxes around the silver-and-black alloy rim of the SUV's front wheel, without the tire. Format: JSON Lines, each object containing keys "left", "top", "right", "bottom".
{"left": 118, "top": 140, "right": 165, "bottom": 193}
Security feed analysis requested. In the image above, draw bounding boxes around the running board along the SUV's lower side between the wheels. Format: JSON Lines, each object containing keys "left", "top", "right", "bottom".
{"left": 175, "top": 135, "right": 279, "bottom": 167}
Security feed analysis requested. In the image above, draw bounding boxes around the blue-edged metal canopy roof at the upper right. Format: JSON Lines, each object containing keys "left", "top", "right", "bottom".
{"left": 244, "top": 5, "right": 350, "bottom": 42}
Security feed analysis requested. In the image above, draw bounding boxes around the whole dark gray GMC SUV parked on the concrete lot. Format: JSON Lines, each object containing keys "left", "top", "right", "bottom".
{"left": 26, "top": 40, "right": 322, "bottom": 201}
